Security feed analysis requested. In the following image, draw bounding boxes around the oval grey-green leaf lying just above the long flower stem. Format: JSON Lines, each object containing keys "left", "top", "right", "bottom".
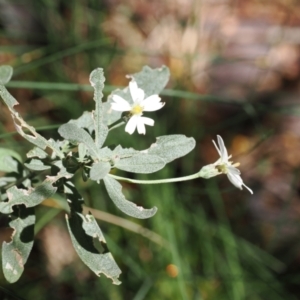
{"left": 114, "top": 152, "right": 166, "bottom": 174}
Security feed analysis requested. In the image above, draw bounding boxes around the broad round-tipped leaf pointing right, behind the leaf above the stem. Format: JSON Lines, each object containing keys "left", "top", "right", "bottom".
{"left": 143, "top": 134, "right": 196, "bottom": 163}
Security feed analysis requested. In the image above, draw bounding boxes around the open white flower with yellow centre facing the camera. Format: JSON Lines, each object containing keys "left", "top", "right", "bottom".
{"left": 111, "top": 80, "right": 165, "bottom": 134}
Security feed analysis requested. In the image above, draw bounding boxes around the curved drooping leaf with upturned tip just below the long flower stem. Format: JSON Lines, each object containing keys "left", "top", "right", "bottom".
{"left": 103, "top": 176, "right": 157, "bottom": 219}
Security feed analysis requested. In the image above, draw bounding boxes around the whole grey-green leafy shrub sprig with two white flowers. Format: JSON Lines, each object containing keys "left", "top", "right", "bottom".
{"left": 0, "top": 65, "right": 252, "bottom": 284}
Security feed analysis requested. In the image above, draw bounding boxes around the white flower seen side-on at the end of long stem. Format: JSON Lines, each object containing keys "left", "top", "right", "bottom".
{"left": 213, "top": 135, "right": 253, "bottom": 194}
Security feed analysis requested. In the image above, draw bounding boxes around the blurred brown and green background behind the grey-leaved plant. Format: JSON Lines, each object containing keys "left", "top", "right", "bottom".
{"left": 0, "top": 0, "right": 300, "bottom": 300}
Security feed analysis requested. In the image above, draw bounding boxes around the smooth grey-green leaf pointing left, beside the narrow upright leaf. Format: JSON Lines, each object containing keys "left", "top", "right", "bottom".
{"left": 58, "top": 123, "right": 98, "bottom": 157}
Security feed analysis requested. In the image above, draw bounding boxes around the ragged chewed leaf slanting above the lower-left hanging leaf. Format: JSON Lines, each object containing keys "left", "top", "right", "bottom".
{"left": 0, "top": 178, "right": 57, "bottom": 214}
